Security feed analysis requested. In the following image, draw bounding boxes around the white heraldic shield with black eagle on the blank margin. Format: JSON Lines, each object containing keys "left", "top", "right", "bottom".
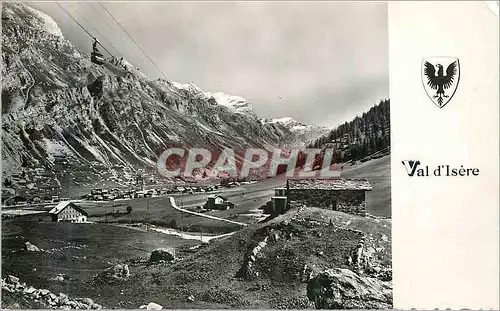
{"left": 422, "top": 57, "right": 460, "bottom": 108}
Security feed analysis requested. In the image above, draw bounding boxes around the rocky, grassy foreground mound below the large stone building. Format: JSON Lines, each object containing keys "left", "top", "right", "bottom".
{"left": 84, "top": 207, "right": 392, "bottom": 309}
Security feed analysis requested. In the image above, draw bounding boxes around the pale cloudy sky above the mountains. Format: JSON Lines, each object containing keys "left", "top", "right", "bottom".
{"left": 30, "top": 2, "right": 389, "bottom": 127}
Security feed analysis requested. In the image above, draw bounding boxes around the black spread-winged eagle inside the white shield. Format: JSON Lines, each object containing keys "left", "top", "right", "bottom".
{"left": 424, "top": 61, "right": 457, "bottom": 106}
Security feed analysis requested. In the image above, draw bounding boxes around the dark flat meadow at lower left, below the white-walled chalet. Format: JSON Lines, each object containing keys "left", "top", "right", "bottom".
{"left": 2, "top": 220, "right": 197, "bottom": 297}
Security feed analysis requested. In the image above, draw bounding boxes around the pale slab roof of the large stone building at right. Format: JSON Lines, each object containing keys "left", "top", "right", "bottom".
{"left": 287, "top": 178, "right": 372, "bottom": 191}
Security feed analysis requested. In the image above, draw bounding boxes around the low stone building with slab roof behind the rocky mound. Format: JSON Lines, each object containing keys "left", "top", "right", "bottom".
{"left": 287, "top": 178, "right": 372, "bottom": 216}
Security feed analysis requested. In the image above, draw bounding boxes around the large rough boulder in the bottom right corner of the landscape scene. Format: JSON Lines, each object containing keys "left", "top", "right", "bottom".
{"left": 307, "top": 268, "right": 392, "bottom": 309}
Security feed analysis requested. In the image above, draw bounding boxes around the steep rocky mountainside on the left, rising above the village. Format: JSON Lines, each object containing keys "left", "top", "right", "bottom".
{"left": 2, "top": 3, "right": 318, "bottom": 193}
